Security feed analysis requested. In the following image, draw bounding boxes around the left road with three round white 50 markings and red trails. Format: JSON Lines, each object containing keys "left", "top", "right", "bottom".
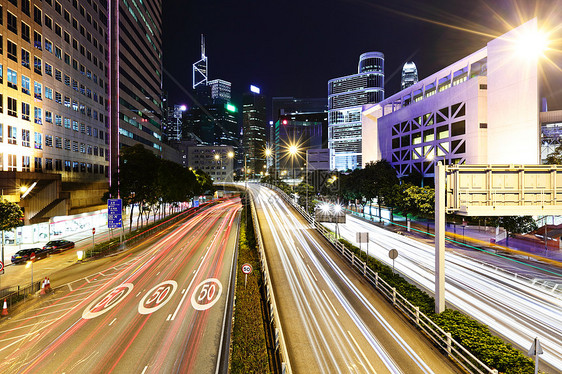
{"left": 0, "top": 201, "right": 240, "bottom": 374}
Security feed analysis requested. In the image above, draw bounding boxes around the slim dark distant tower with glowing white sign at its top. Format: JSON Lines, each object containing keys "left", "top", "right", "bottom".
{"left": 242, "top": 86, "right": 267, "bottom": 176}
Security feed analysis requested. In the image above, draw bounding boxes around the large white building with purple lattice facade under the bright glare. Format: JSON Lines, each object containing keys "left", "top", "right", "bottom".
{"left": 362, "top": 19, "right": 540, "bottom": 177}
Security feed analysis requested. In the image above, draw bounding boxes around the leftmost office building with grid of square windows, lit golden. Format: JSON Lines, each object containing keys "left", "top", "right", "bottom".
{"left": 0, "top": 0, "right": 109, "bottom": 224}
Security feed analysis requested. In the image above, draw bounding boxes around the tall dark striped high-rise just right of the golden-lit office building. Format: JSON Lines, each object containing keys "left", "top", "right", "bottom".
{"left": 108, "top": 0, "right": 162, "bottom": 183}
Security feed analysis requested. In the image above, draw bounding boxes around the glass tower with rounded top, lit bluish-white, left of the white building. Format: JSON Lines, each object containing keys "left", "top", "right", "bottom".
{"left": 328, "top": 52, "right": 384, "bottom": 170}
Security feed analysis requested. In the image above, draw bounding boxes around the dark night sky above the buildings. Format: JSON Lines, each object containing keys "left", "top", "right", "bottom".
{"left": 163, "top": 0, "right": 562, "bottom": 119}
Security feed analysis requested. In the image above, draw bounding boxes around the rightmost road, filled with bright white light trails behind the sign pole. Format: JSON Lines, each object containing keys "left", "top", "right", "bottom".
{"left": 326, "top": 215, "right": 562, "bottom": 373}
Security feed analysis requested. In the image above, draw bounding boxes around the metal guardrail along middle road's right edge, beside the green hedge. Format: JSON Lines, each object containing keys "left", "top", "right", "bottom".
{"left": 266, "top": 185, "right": 498, "bottom": 374}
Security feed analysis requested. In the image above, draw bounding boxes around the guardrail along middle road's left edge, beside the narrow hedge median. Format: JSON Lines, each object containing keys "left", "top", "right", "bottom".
{"left": 246, "top": 189, "right": 292, "bottom": 374}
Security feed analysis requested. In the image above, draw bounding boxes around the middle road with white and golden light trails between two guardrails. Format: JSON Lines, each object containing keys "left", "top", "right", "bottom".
{"left": 250, "top": 184, "right": 458, "bottom": 373}
